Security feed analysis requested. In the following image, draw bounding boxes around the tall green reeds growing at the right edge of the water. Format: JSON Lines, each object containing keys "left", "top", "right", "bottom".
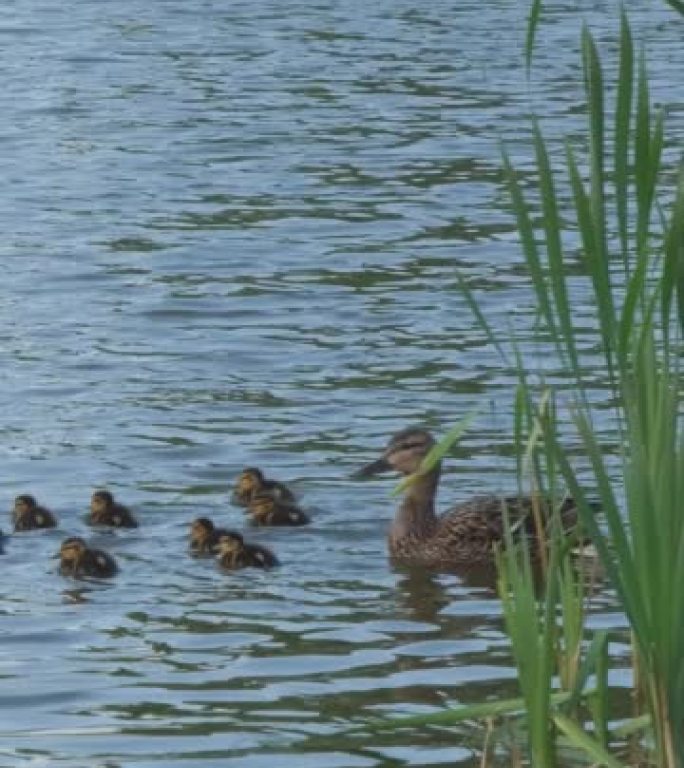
{"left": 368, "top": 6, "right": 684, "bottom": 768}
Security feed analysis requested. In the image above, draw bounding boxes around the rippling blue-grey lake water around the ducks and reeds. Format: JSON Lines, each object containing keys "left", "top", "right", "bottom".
{"left": 0, "top": 0, "right": 684, "bottom": 768}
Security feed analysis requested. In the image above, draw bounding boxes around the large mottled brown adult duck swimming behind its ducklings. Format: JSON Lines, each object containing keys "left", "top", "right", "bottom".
{"left": 356, "top": 428, "right": 596, "bottom": 568}
